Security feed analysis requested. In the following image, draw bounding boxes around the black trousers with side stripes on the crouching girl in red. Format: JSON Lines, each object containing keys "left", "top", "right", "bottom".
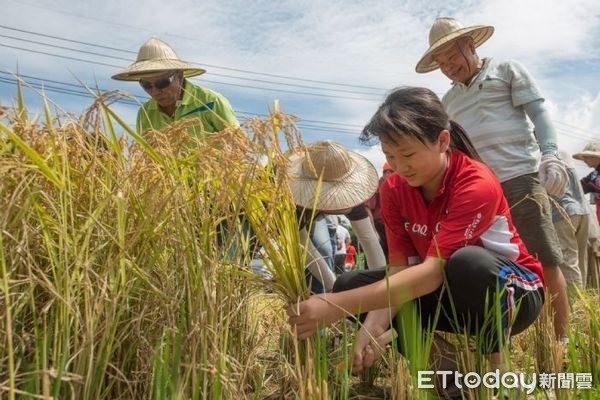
{"left": 333, "top": 246, "right": 544, "bottom": 354}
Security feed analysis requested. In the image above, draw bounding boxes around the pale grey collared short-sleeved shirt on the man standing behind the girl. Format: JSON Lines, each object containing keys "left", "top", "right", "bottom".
{"left": 442, "top": 58, "right": 543, "bottom": 182}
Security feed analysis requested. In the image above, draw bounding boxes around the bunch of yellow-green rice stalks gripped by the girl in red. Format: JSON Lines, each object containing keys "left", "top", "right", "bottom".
{"left": 240, "top": 112, "right": 342, "bottom": 399}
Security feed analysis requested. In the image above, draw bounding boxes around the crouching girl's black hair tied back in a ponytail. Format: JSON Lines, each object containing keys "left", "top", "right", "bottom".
{"left": 360, "top": 87, "right": 481, "bottom": 161}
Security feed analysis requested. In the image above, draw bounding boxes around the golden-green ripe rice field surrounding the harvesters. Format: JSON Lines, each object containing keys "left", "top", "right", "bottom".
{"left": 0, "top": 87, "right": 600, "bottom": 400}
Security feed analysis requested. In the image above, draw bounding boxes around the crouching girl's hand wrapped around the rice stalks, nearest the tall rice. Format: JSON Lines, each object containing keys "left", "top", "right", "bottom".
{"left": 286, "top": 293, "right": 344, "bottom": 339}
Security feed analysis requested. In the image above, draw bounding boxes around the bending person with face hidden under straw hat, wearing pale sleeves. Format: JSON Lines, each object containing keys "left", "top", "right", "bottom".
{"left": 288, "top": 140, "right": 385, "bottom": 293}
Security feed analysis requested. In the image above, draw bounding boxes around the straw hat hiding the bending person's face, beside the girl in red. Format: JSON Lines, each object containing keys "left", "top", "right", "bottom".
{"left": 288, "top": 140, "right": 378, "bottom": 211}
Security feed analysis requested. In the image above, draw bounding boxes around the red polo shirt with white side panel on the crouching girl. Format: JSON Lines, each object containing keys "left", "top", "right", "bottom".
{"left": 381, "top": 151, "right": 543, "bottom": 280}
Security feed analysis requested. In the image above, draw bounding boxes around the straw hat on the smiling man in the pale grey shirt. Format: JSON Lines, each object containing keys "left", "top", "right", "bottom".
{"left": 415, "top": 17, "right": 494, "bottom": 73}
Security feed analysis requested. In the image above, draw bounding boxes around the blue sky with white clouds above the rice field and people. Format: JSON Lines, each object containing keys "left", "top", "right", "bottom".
{"left": 0, "top": 0, "right": 600, "bottom": 176}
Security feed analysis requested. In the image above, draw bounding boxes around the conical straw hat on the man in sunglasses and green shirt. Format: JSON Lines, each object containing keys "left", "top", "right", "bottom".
{"left": 112, "top": 37, "right": 206, "bottom": 81}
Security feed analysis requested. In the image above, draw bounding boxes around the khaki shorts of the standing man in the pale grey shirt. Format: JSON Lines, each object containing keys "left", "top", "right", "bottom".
{"left": 501, "top": 173, "right": 562, "bottom": 267}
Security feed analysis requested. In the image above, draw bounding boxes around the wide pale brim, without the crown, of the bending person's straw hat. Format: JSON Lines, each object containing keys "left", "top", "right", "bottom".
{"left": 288, "top": 151, "right": 379, "bottom": 212}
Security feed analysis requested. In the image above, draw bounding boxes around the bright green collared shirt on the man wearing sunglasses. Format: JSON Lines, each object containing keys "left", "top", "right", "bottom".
{"left": 136, "top": 80, "right": 239, "bottom": 136}
